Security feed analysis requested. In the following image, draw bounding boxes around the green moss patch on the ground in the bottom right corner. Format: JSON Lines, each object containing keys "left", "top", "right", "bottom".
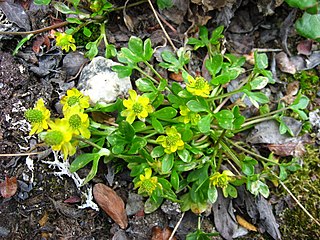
{"left": 280, "top": 146, "right": 320, "bottom": 240}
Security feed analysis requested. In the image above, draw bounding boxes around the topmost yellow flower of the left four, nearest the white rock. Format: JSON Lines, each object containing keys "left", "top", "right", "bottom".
{"left": 60, "top": 88, "right": 90, "bottom": 114}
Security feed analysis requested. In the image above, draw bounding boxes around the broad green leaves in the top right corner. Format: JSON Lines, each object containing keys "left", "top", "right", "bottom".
{"left": 285, "top": 0, "right": 320, "bottom": 42}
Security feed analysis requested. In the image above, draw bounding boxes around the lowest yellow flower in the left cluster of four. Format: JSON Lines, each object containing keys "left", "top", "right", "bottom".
{"left": 40, "top": 119, "right": 76, "bottom": 159}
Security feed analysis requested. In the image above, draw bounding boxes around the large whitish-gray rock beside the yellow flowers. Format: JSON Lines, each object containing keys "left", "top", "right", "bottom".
{"left": 78, "top": 57, "right": 132, "bottom": 104}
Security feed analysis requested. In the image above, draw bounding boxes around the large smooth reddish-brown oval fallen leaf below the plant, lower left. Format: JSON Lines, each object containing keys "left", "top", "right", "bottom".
{"left": 93, "top": 183, "right": 128, "bottom": 229}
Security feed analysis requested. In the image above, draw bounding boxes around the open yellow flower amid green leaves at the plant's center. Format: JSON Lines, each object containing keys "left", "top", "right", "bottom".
{"left": 156, "top": 126, "right": 184, "bottom": 154}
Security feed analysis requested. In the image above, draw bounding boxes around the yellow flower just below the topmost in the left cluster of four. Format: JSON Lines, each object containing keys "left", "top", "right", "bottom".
{"left": 64, "top": 106, "right": 90, "bottom": 139}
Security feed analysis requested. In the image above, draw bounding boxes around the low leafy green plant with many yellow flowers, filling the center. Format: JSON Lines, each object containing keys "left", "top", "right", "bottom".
{"left": 25, "top": 27, "right": 309, "bottom": 236}
